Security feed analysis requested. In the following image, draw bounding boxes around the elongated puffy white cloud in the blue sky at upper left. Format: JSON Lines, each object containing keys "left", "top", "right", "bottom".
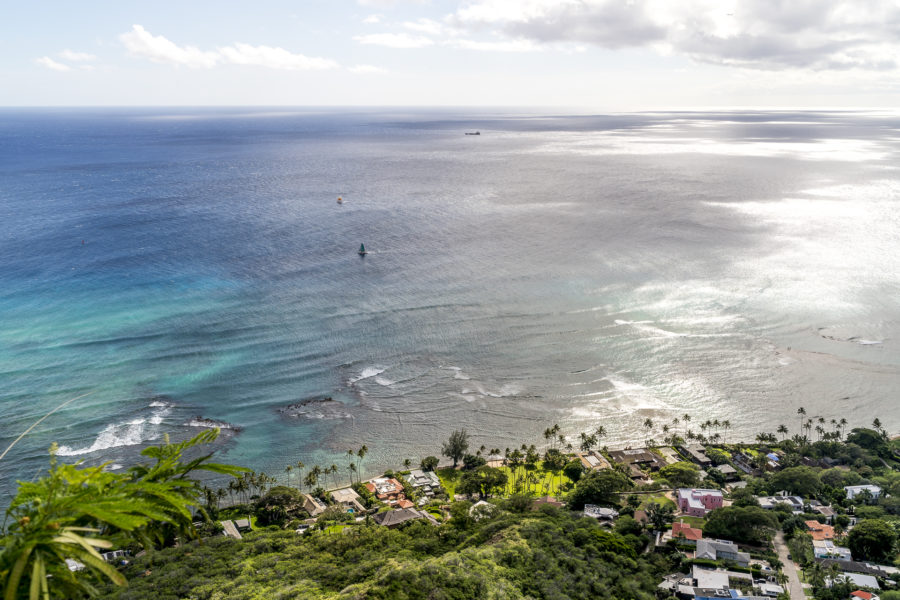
{"left": 119, "top": 25, "right": 338, "bottom": 71}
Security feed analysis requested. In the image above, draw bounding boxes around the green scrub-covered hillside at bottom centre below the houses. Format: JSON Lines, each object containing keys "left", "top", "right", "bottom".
{"left": 102, "top": 507, "right": 669, "bottom": 600}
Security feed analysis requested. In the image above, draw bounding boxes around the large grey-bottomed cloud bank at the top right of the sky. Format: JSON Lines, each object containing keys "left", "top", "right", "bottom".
{"left": 447, "top": 0, "right": 900, "bottom": 71}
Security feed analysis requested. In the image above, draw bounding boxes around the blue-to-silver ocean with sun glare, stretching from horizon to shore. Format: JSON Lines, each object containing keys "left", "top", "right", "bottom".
{"left": 0, "top": 108, "right": 900, "bottom": 493}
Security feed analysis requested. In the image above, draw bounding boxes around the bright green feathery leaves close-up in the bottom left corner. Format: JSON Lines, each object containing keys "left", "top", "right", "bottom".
{"left": 0, "top": 430, "right": 245, "bottom": 600}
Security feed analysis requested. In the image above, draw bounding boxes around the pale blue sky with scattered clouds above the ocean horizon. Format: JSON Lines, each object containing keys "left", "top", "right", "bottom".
{"left": 0, "top": 0, "right": 900, "bottom": 110}
